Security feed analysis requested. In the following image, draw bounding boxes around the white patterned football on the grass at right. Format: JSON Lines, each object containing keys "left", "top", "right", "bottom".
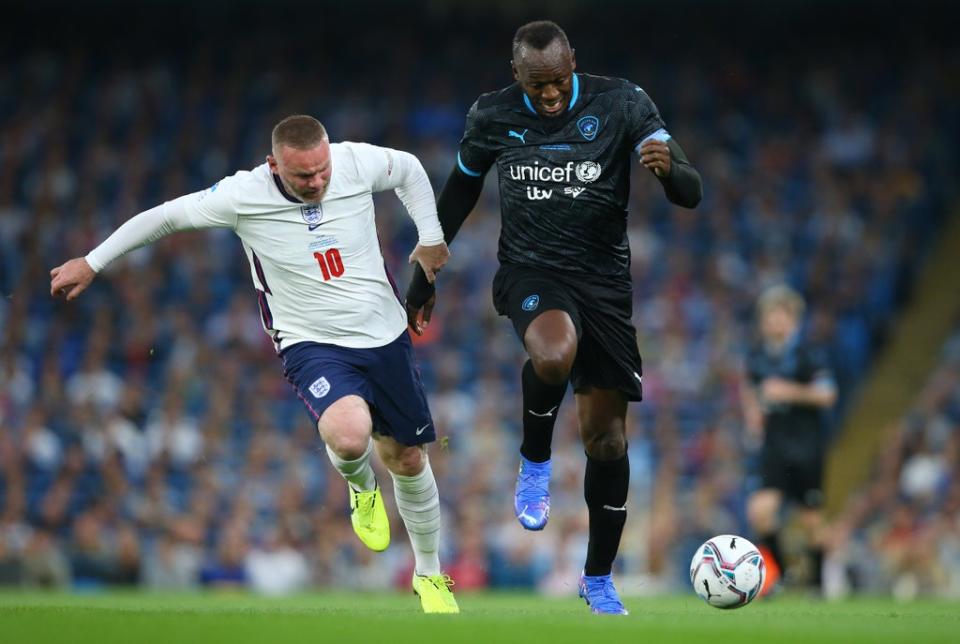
{"left": 690, "top": 534, "right": 766, "bottom": 608}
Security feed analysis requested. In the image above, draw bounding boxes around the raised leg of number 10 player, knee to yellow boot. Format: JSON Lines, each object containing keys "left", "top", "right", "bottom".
{"left": 317, "top": 395, "right": 390, "bottom": 552}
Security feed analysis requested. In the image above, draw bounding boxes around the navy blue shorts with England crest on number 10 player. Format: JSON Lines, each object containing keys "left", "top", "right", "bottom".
{"left": 280, "top": 331, "right": 437, "bottom": 445}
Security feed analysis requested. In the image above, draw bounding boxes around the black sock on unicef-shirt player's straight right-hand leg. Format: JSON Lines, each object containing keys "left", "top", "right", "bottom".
{"left": 583, "top": 454, "right": 630, "bottom": 577}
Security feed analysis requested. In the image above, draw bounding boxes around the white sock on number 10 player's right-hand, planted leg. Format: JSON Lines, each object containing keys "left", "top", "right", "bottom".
{"left": 390, "top": 456, "right": 440, "bottom": 576}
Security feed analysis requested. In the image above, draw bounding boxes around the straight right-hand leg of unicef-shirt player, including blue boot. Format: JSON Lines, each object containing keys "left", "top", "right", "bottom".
{"left": 577, "top": 389, "right": 630, "bottom": 615}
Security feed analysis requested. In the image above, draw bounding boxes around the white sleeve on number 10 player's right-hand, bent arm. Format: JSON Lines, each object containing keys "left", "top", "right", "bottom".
{"left": 350, "top": 143, "right": 443, "bottom": 246}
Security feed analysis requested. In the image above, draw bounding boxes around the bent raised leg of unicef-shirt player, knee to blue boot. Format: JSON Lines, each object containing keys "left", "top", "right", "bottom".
{"left": 514, "top": 309, "right": 577, "bottom": 530}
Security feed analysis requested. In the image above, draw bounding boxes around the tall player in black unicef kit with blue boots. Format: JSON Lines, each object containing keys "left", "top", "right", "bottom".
{"left": 407, "top": 21, "right": 701, "bottom": 615}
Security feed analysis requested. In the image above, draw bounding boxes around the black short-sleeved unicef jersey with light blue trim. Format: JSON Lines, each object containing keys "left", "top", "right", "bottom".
{"left": 457, "top": 74, "right": 669, "bottom": 279}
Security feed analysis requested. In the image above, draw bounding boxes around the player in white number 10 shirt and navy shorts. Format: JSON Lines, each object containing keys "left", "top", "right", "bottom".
{"left": 50, "top": 115, "right": 459, "bottom": 613}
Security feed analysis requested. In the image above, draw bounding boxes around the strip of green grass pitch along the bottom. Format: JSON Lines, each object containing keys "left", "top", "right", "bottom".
{"left": 0, "top": 591, "right": 960, "bottom": 644}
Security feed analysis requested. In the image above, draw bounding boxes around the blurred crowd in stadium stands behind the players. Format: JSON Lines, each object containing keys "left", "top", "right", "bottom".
{"left": 0, "top": 1, "right": 960, "bottom": 596}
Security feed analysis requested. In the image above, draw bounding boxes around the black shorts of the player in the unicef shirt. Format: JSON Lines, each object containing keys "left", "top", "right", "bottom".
{"left": 493, "top": 264, "right": 643, "bottom": 400}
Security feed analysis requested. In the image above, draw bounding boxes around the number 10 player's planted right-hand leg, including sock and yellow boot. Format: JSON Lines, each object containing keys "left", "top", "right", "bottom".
{"left": 376, "top": 436, "right": 460, "bottom": 613}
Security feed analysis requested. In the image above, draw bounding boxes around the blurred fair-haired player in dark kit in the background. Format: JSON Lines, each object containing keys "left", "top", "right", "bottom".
{"left": 741, "top": 286, "right": 837, "bottom": 594}
